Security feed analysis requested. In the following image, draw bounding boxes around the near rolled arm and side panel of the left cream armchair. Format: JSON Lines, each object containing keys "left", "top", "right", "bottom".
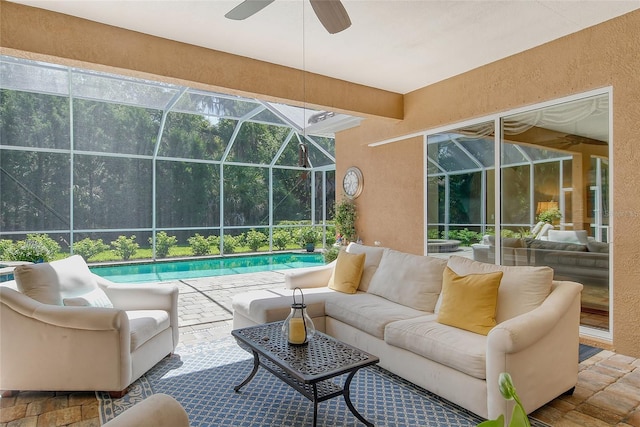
{"left": 0, "top": 286, "right": 132, "bottom": 391}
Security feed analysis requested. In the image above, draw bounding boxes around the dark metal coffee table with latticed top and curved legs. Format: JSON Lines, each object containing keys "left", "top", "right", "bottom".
{"left": 231, "top": 322, "right": 379, "bottom": 426}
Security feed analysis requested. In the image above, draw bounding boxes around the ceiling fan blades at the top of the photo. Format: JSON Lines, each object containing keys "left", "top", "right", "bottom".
{"left": 224, "top": 0, "right": 351, "bottom": 34}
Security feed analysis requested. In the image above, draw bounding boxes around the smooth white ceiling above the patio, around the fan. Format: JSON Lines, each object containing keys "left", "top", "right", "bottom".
{"left": 8, "top": 0, "right": 640, "bottom": 94}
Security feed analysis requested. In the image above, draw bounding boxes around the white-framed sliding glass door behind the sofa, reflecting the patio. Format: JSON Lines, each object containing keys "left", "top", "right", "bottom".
{"left": 425, "top": 92, "right": 611, "bottom": 331}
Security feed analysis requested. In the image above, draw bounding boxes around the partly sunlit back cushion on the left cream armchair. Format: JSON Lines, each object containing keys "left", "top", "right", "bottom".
{"left": 13, "top": 255, "right": 98, "bottom": 305}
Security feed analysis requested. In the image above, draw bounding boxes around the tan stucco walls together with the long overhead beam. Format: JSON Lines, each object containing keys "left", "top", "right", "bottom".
{"left": 0, "top": 1, "right": 640, "bottom": 357}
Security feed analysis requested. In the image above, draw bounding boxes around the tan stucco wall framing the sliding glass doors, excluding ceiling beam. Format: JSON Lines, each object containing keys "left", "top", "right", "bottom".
{"left": 337, "top": 12, "right": 640, "bottom": 357}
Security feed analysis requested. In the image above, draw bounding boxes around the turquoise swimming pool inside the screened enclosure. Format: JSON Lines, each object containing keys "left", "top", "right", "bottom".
{"left": 90, "top": 253, "right": 324, "bottom": 283}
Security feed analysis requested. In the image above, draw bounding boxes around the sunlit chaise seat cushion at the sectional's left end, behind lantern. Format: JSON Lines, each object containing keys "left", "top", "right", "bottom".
{"left": 232, "top": 287, "right": 336, "bottom": 324}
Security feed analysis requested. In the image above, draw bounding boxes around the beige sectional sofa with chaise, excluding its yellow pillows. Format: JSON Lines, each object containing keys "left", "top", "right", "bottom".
{"left": 233, "top": 243, "right": 582, "bottom": 418}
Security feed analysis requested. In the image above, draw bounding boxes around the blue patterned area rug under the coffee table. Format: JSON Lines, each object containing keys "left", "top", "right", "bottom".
{"left": 97, "top": 338, "right": 546, "bottom": 427}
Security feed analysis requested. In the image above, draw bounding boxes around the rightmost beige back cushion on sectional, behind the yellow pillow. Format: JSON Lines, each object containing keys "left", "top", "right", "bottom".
{"left": 447, "top": 256, "right": 553, "bottom": 323}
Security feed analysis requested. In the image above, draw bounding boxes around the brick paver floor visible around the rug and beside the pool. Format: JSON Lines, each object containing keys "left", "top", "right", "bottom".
{"left": 0, "top": 272, "right": 640, "bottom": 427}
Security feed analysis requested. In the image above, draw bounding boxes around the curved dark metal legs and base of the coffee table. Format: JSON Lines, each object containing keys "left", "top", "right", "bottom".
{"left": 233, "top": 350, "right": 374, "bottom": 427}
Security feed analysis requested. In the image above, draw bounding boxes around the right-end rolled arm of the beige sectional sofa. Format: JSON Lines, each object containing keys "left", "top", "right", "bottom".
{"left": 486, "top": 281, "right": 582, "bottom": 422}
